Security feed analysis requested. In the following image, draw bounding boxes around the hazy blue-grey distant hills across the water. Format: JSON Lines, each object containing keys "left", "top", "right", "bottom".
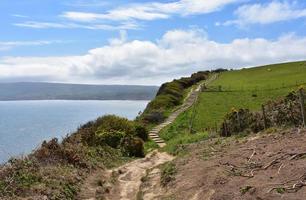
{"left": 0, "top": 82, "right": 158, "bottom": 101}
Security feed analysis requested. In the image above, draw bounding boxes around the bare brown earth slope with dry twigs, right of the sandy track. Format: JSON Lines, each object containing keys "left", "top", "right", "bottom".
{"left": 151, "top": 129, "right": 306, "bottom": 200}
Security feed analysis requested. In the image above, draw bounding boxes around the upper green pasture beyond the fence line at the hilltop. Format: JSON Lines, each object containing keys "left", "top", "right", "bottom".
{"left": 212, "top": 62, "right": 306, "bottom": 90}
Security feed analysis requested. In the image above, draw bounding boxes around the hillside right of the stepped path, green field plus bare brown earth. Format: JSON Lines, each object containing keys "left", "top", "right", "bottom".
{"left": 134, "top": 62, "right": 306, "bottom": 200}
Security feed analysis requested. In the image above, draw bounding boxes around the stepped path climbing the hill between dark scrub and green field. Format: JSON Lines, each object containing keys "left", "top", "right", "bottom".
{"left": 149, "top": 74, "right": 217, "bottom": 147}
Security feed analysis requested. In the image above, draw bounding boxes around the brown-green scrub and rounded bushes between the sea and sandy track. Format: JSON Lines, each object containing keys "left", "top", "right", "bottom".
{"left": 0, "top": 115, "right": 148, "bottom": 199}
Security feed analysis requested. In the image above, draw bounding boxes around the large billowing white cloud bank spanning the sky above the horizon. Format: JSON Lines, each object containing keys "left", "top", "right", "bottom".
{"left": 0, "top": 30, "right": 306, "bottom": 84}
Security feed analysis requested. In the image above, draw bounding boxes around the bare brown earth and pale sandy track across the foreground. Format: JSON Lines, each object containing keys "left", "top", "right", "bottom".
{"left": 81, "top": 128, "right": 306, "bottom": 200}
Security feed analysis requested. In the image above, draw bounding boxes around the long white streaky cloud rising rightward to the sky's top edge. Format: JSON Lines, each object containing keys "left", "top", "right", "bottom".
{"left": 62, "top": 0, "right": 241, "bottom": 22}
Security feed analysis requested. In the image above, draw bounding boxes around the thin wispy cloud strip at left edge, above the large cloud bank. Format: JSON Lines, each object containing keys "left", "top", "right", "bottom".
{"left": 0, "top": 40, "right": 62, "bottom": 51}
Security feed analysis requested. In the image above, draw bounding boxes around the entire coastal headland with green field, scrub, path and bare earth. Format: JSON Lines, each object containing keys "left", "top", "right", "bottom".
{"left": 0, "top": 62, "right": 306, "bottom": 200}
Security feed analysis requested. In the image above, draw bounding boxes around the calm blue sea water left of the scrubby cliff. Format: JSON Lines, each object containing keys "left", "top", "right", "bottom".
{"left": 0, "top": 100, "right": 148, "bottom": 163}
